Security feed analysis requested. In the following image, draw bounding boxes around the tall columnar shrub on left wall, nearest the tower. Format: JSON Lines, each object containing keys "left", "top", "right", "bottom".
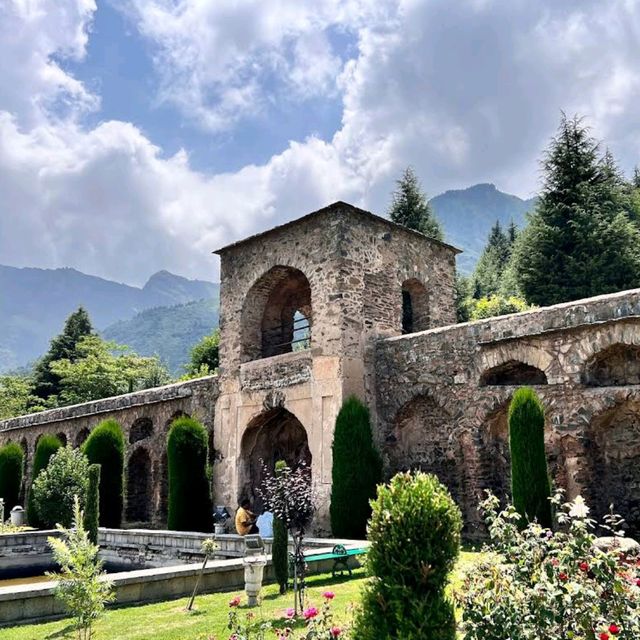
{"left": 167, "top": 416, "right": 213, "bottom": 531}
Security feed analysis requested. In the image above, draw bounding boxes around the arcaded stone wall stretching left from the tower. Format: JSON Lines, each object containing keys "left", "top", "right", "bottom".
{"left": 0, "top": 376, "right": 218, "bottom": 526}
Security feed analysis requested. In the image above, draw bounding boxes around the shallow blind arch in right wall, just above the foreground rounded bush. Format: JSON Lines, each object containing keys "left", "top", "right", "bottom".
{"left": 385, "top": 395, "right": 465, "bottom": 507}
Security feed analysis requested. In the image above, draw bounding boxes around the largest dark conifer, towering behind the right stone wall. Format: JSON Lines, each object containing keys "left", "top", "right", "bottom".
{"left": 514, "top": 115, "right": 640, "bottom": 305}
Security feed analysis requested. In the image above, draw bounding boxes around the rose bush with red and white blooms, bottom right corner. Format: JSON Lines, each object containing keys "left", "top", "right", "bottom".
{"left": 456, "top": 493, "right": 640, "bottom": 640}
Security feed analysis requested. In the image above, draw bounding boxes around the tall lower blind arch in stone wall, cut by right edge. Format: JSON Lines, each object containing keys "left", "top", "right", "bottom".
{"left": 586, "top": 400, "right": 640, "bottom": 535}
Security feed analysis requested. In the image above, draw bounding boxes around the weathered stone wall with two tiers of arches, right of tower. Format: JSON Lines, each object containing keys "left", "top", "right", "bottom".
{"left": 376, "top": 290, "right": 640, "bottom": 535}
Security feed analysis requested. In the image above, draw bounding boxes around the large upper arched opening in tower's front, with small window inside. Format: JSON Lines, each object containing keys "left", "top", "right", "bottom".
{"left": 241, "top": 266, "right": 313, "bottom": 362}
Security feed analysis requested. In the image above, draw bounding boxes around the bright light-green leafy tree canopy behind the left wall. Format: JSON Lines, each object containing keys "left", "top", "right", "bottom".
{"left": 50, "top": 335, "right": 168, "bottom": 405}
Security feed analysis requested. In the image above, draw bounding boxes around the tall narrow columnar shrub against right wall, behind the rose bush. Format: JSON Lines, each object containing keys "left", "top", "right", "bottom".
{"left": 509, "top": 387, "right": 551, "bottom": 527}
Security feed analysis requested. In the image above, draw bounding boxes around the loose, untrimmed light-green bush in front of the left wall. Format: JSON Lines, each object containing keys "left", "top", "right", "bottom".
{"left": 33, "top": 445, "right": 89, "bottom": 528}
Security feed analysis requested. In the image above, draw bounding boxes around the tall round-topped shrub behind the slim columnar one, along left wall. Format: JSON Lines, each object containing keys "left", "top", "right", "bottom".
{"left": 82, "top": 420, "right": 125, "bottom": 529}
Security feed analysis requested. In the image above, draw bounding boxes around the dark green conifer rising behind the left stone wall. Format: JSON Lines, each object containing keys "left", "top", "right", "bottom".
{"left": 33, "top": 307, "right": 94, "bottom": 400}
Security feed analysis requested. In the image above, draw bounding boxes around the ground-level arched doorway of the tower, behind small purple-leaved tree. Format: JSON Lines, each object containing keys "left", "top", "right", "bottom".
{"left": 238, "top": 407, "right": 311, "bottom": 510}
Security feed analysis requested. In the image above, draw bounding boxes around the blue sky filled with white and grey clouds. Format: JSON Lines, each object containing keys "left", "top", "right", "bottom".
{"left": 0, "top": 0, "right": 640, "bottom": 284}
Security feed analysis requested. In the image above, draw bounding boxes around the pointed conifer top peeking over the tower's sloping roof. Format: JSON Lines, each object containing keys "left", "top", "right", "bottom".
{"left": 388, "top": 167, "right": 444, "bottom": 240}
